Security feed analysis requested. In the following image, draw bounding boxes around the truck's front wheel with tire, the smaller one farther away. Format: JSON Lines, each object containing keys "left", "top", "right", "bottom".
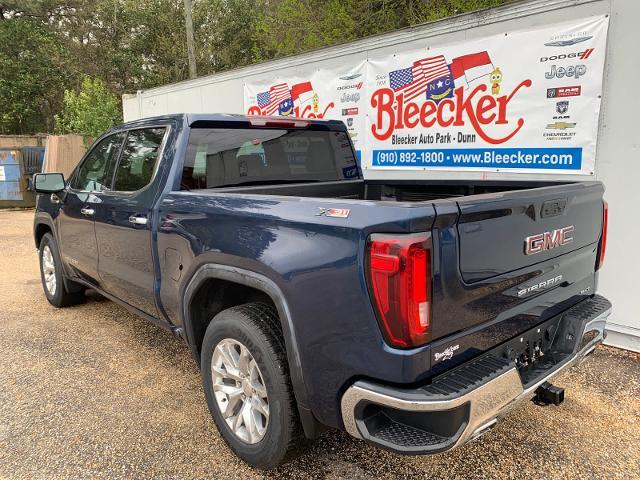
{"left": 38, "top": 233, "right": 84, "bottom": 308}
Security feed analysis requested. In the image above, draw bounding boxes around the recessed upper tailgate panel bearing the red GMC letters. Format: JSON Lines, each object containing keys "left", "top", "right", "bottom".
{"left": 458, "top": 182, "right": 604, "bottom": 283}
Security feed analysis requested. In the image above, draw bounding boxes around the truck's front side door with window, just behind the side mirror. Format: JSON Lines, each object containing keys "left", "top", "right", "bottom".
{"left": 58, "top": 133, "right": 124, "bottom": 286}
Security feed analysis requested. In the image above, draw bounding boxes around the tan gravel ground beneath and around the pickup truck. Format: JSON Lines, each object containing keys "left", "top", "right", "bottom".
{"left": 0, "top": 211, "right": 640, "bottom": 479}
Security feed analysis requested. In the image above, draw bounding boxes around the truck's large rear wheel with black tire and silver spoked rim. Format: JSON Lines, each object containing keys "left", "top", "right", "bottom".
{"left": 201, "top": 303, "right": 303, "bottom": 468}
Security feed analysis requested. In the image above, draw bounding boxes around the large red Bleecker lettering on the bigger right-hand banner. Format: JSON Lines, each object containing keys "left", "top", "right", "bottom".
{"left": 371, "top": 80, "right": 531, "bottom": 144}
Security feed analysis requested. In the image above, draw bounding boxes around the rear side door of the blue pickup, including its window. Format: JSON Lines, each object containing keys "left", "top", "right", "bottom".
{"left": 95, "top": 126, "right": 168, "bottom": 317}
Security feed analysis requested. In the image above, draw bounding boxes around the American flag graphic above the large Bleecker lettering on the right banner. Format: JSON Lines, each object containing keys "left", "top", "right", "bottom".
{"left": 389, "top": 55, "right": 449, "bottom": 100}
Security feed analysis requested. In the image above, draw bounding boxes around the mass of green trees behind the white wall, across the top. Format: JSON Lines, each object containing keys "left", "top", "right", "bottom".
{"left": 0, "top": 0, "right": 509, "bottom": 133}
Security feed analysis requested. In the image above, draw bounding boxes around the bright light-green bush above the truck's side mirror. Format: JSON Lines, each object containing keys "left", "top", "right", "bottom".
{"left": 55, "top": 77, "right": 122, "bottom": 138}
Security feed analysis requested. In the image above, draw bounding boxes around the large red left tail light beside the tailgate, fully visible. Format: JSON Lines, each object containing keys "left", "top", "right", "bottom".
{"left": 367, "top": 233, "right": 431, "bottom": 348}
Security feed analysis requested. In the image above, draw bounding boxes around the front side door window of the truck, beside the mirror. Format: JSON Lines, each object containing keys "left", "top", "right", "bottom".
{"left": 71, "top": 133, "right": 124, "bottom": 192}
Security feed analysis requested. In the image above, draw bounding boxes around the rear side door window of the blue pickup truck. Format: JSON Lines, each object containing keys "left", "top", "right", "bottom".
{"left": 113, "top": 127, "right": 165, "bottom": 192}
